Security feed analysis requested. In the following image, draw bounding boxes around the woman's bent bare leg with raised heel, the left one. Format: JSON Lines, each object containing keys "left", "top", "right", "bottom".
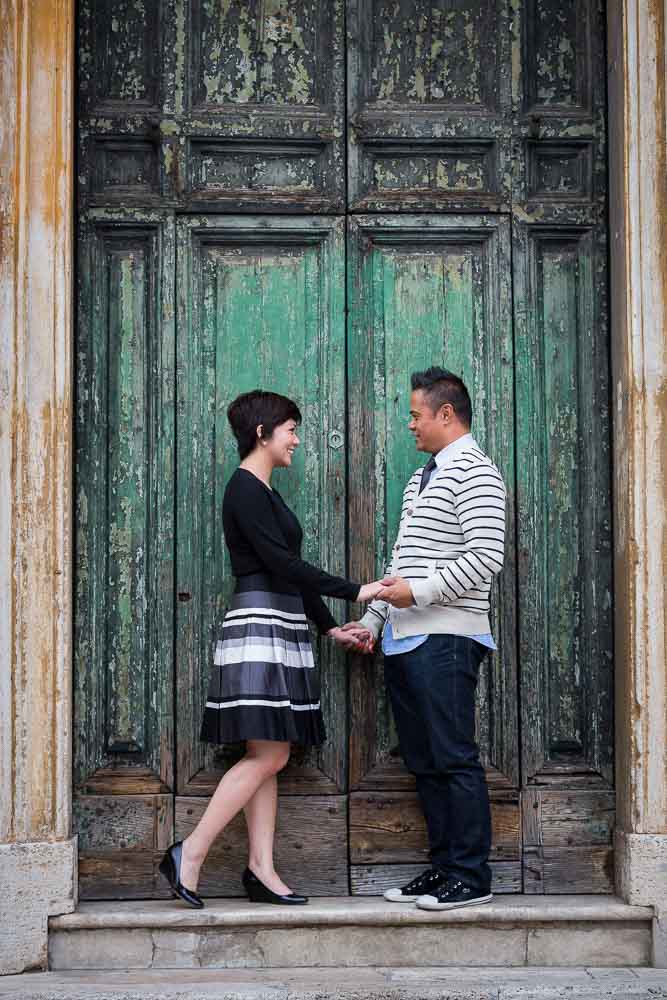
{"left": 181, "top": 740, "right": 290, "bottom": 891}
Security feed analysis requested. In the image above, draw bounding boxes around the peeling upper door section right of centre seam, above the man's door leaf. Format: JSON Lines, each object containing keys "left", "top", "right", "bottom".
{"left": 347, "top": 0, "right": 512, "bottom": 211}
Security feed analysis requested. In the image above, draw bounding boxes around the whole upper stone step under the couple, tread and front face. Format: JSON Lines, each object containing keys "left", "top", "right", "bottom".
{"left": 49, "top": 895, "right": 653, "bottom": 970}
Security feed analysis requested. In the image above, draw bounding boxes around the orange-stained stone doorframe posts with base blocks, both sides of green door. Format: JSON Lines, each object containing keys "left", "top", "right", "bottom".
{"left": 0, "top": 0, "right": 667, "bottom": 972}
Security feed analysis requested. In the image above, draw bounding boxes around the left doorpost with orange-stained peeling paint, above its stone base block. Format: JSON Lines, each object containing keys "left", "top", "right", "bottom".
{"left": 0, "top": 0, "right": 73, "bottom": 842}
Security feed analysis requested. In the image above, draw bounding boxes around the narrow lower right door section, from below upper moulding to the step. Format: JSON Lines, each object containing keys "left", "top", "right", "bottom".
{"left": 515, "top": 226, "right": 613, "bottom": 892}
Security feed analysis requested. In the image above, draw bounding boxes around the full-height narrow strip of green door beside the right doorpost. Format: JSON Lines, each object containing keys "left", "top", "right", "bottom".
{"left": 512, "top": 0, "right": 614, "bottom": 892}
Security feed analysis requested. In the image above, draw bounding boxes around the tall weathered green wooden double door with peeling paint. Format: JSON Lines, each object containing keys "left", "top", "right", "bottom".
{"left": 74, "top": 0, "right": 614, "bottom": 898}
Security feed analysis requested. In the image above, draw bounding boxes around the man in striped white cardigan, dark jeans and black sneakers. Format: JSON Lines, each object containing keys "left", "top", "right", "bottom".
{"left": 345, "top": 368, "right": 506, "bottom": 910}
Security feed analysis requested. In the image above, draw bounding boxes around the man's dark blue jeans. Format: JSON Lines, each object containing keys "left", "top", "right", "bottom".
{"left": 385, "top": 635, "right": 491, "bottom": 892}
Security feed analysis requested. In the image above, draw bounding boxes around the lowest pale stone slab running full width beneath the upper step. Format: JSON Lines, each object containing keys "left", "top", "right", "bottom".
{"left": 0, "top": 967, "right": 667, "bottom": 1000}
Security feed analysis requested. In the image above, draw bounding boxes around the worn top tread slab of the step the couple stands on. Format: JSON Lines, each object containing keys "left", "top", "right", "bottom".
{"left": 49, "top": 895, "right": 653, "bottom": 931}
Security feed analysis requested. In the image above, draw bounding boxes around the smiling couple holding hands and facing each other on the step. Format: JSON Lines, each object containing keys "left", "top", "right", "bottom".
{"left": 160, "top": 368, "right": 506, "bottom": 910}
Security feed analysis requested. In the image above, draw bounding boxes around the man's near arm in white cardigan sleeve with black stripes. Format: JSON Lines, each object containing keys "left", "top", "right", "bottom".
{"left": 410, "top": 466, "right": 506, "bottom": 607}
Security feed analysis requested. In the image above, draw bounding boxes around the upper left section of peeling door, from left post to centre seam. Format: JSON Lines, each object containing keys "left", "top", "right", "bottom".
{"left": 79, "top": 0, "right": 345, "bottom": 213}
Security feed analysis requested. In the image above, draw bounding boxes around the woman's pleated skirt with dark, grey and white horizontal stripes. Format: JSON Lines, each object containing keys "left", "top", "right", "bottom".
{"left": 200, "top": 573, "right": 325, "bottom": 746}
